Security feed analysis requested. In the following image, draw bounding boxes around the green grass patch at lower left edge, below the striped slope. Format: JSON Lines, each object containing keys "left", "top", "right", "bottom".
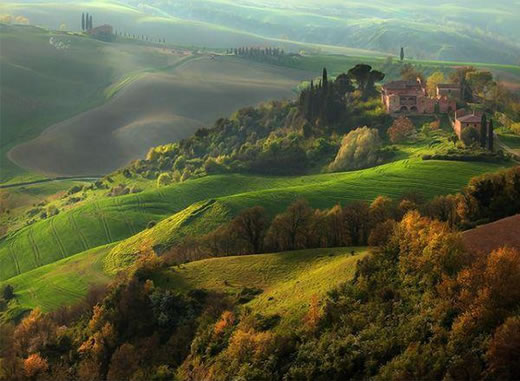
{"left": 0, "top": 245, "right": 112, "bottom": 320}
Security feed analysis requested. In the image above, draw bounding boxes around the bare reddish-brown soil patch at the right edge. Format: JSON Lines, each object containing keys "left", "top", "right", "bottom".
{"left": 462, "top": 214, "right": 520, "bottom": 253}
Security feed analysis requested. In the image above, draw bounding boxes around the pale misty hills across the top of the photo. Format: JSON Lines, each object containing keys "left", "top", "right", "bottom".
{"left": 4, "top": 0, "right": 520, "bottom": 64}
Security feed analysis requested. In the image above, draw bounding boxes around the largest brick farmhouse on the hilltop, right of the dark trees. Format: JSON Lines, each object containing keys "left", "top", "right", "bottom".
{"left": 381, "top": 78, "right": 457, "bottom": 114}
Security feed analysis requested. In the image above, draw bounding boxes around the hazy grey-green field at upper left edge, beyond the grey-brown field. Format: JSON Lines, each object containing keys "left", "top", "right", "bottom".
{"left": 0, "top": 24, "right": 181, "bottom": 182}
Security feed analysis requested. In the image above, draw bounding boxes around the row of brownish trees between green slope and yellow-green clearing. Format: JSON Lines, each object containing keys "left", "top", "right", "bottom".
{"left": 162, "top": 167, "right": 520, "bottom": 263}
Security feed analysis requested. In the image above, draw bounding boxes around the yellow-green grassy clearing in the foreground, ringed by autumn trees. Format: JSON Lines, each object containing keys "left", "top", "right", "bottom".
{"left": 155, "top": 248, "right": 368, "bottom": 329}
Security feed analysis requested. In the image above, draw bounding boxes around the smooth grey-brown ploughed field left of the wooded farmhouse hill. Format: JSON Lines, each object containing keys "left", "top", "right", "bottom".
{"left": 9, "top": 56, "right": 310, "bottom": 175}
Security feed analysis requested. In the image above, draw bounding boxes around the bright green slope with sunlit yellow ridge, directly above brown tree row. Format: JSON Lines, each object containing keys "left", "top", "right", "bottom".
{"left": 105, "top": 159, "right": 508, "bottom": 272}
